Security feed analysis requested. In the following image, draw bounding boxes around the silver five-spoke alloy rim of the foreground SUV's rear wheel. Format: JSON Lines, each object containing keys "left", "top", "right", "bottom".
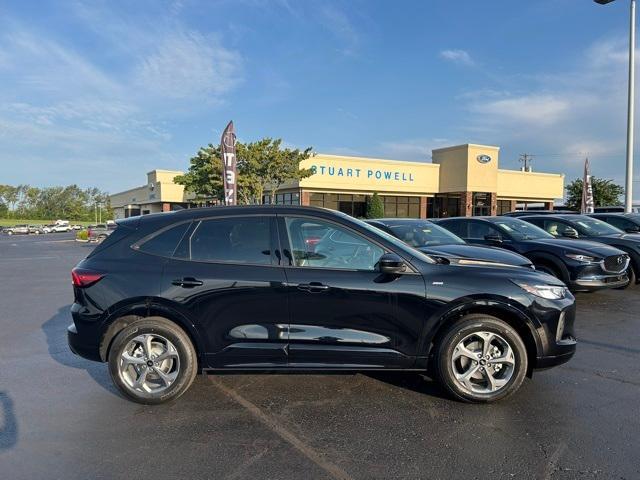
{"left": 118, "top": 333, "right": 180, "bottom": 394}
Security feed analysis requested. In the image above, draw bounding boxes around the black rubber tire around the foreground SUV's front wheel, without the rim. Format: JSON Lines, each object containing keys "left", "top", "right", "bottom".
{"left": 433, "top": 314, "right": 528, "bottom": 403}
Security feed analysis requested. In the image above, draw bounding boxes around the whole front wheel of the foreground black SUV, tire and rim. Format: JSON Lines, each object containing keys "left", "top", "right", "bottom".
{"left": 434, "top": 314, "right": 528, "bottom": 403}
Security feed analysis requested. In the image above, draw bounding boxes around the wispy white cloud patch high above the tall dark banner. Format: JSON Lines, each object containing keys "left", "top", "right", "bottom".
{"left": 135, "top": 33, "right": 241, "bottom": 100}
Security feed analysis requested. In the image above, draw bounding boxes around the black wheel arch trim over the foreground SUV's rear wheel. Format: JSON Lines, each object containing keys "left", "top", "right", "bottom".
{"left": 100, "top": 297, "right": 205, "bottom": 361}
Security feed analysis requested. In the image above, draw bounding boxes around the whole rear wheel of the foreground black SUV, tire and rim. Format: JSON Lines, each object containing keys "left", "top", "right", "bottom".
{"left": 108, "top": 317, "right": 198, "bottom": 405}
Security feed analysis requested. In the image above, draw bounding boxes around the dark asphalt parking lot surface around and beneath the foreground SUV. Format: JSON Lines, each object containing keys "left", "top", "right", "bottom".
{"left": 0, "top": 234, "right": 640, "bottom": 480}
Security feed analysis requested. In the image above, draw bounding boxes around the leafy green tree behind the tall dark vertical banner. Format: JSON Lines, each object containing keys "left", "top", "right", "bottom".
{"left": 174, "top": 138, "right": 313, "bottom": 204}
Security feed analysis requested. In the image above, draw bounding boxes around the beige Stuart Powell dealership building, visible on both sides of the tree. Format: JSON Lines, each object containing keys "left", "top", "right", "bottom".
{"left": 110, "top": 144, "right": 564, "bottom": 218}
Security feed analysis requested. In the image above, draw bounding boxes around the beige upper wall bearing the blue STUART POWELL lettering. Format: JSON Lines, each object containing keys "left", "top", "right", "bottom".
{"left": 299, "top": 154, "right": 440, "bottom": 195}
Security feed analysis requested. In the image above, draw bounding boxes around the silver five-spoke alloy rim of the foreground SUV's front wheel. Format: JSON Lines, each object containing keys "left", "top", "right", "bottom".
{"left": 451, "top": 331, "right": 515, "bottom": 394}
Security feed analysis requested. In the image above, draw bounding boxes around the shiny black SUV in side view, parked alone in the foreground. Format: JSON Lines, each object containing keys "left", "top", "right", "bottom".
{"left": 68, "top": 206, "right": 576, "bottom": 404}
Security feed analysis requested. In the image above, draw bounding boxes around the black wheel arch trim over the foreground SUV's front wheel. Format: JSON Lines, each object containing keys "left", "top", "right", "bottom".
{"left": 418, "top": 295, "right": 545, "bottom": 368}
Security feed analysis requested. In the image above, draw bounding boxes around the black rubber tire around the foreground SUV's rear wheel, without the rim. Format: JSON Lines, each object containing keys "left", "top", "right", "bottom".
{"left": 108, "top": 317, "right": 198, "bottom": 405}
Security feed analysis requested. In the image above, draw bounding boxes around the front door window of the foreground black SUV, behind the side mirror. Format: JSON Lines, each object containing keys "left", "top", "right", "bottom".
{"left": 285, "top": 217, "right": 384, "bottom": 271}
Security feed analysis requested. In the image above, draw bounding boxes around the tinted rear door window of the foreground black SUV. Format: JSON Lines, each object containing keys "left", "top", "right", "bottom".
{"left": 180, "top": 217, "right": 271, "bottom": 265}
